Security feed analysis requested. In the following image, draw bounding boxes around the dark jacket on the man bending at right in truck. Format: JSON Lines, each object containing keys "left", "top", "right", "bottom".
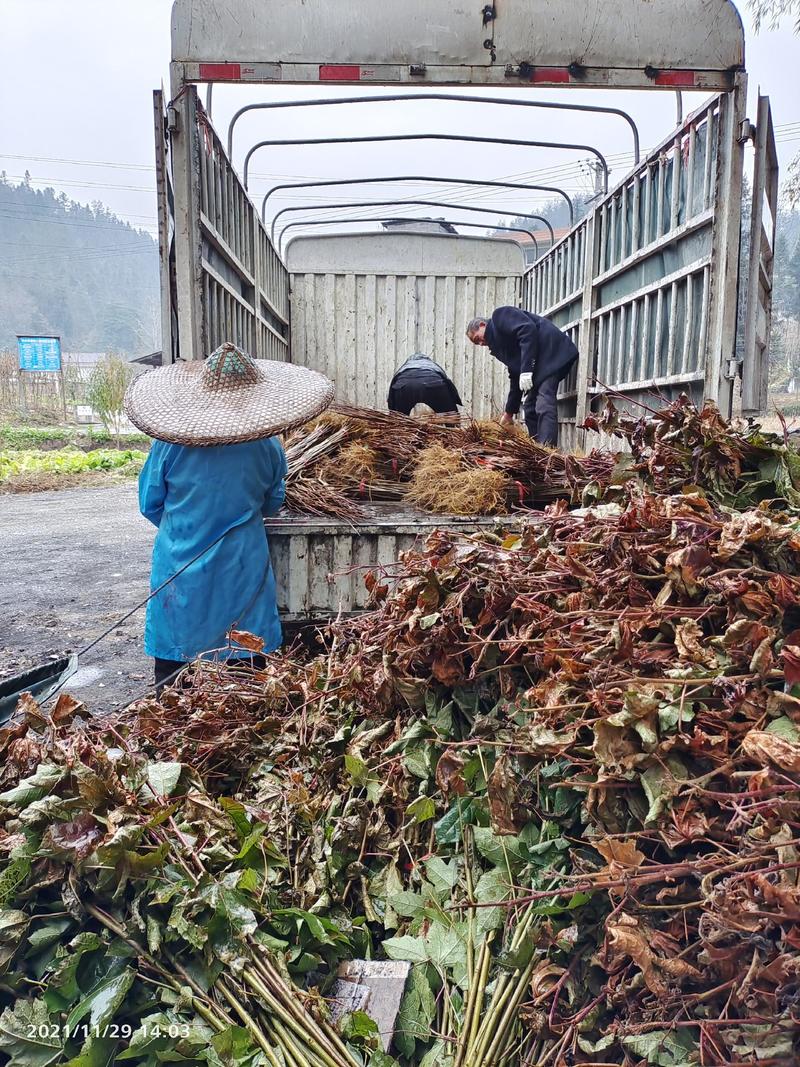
{"left": 486, "top": 307, "right": 578, "bottom": 415}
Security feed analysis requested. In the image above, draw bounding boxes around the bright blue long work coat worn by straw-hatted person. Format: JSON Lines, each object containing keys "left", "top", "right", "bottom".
{"left": 139, "top": 437, "right": 287, "bottom": 663}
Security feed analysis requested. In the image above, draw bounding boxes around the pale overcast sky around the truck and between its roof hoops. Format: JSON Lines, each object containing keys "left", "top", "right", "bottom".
{"left": 0, "top": 0, "right": 800, "bottom": 245}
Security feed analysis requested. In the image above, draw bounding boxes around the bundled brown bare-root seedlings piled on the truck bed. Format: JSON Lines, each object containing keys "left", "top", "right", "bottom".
{"left": 287, "top": 407, "right": 618, "bottom": 520}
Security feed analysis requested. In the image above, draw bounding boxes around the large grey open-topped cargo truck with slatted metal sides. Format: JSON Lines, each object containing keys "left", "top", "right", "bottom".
{"left": 154, "top": 0, "right": 778, "bottom": 619}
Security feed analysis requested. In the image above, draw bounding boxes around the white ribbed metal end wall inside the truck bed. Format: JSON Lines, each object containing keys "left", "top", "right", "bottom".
{"left": 291, "top": 272, "right": 522, "bottom": 418}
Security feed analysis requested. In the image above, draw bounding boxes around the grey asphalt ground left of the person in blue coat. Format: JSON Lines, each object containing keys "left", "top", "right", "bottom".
{"left": 0, "top": 482, "right": 156, "bottom": 712}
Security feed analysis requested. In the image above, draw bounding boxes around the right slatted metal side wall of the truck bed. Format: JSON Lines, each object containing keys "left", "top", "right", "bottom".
{"left": 524, "top": 93, "right": 755, "bottom": 446}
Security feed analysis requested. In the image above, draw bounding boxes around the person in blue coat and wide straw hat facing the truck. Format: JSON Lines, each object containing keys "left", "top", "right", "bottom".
{"left": 125, "top": 344, "right": 334, "bottom": 689}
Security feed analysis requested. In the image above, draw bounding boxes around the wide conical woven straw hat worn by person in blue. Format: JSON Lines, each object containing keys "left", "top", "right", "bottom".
{"left": 125, "top": 341, "right": 334, "bottom": 445}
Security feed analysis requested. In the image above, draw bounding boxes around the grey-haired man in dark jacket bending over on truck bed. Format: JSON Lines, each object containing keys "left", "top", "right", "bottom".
{"left": 467, "top": 307, "right": 578, "bottom": 446}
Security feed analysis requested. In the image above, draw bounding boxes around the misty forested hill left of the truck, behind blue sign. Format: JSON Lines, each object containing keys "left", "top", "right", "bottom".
{"left": 0, "top": 178, "right": 161, "bottom": 355}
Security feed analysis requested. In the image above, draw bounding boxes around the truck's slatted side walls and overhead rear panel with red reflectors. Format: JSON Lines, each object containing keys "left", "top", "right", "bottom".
{"left": 156, "top": 0, "right": 778, "bottom": 433}
